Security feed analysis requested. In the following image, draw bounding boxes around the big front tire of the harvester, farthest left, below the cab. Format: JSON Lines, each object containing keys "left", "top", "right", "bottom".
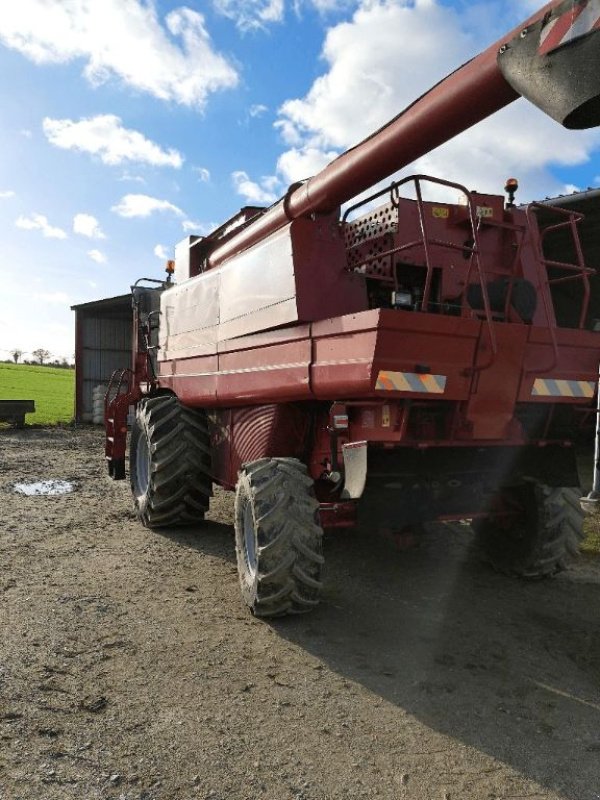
{"left": 129, "top": 395, "right": 212, "bottom": 528}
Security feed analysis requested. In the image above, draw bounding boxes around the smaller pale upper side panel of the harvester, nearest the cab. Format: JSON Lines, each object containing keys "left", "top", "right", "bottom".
{"left": 158, "top": 269, "right": 221, "bottom": 361}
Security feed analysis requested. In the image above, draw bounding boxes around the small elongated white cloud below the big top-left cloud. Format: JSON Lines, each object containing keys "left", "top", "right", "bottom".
{"left": 43, "top": 114, "right": 183, "bottom": 169}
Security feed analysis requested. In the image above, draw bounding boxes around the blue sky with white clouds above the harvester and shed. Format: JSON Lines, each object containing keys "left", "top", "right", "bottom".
{"left": 0, "top": 0, "right": 600, "bottom": 357}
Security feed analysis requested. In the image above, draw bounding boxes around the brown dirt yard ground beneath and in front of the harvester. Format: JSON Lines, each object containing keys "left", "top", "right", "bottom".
{"left": 0, "top": 429, "right": 600, "bottom": 800}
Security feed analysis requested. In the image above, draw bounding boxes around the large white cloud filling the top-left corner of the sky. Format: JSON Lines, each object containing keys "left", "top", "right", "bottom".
{"left": 0, "top": 0, "right": 238, "bottom": 108}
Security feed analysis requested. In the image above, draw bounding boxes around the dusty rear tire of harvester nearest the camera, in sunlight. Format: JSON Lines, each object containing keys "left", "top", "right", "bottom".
{"left": 235, "top": 458, "right": 324, "bottom": 617}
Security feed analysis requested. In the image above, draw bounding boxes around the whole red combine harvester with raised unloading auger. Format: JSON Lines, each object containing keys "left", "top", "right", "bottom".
{"left": 106, "top": 0, "right": 600, "bottom": 616}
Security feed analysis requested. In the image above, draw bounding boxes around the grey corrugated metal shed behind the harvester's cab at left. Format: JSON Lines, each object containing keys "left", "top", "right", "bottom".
{"left": 75, "top": 296, "right": 133, "bottom": 422}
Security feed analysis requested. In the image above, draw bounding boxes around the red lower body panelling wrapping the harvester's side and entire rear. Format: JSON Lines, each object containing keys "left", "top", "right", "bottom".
{"left": 159, "top": 309, "right": 599, "bottom": 418}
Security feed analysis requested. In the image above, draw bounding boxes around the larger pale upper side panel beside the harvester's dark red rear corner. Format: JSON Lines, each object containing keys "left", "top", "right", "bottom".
{"left": 219, "top": 226, "right": 297, "bottom": 324}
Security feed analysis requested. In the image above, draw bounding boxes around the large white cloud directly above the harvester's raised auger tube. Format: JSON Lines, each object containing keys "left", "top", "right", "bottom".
{"left": 280, "top": 0, "right": 474, "bottom": 149}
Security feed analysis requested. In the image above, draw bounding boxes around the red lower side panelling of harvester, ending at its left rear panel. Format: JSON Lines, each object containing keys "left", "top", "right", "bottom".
{"left": 159, "top": 309, "right": 482, "bottom": 407}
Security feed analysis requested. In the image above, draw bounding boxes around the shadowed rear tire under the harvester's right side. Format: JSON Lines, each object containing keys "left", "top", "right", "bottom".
{"left": 473, "top": 481, "right": 584, "bottom": 578}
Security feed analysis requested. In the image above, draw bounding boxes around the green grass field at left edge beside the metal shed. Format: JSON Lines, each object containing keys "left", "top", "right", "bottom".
{"left": 0, "top": 364, "right": 75, "bottom": 425}
